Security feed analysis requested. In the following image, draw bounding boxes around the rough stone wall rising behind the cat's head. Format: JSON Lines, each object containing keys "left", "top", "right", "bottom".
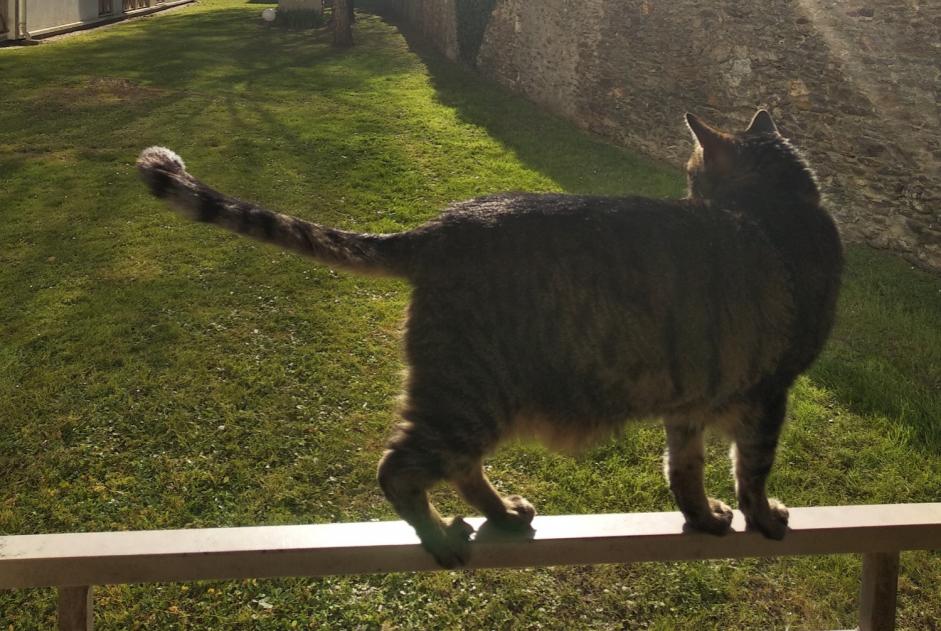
{"left": 386, "top": 0, "right": 941, "bottom": 270}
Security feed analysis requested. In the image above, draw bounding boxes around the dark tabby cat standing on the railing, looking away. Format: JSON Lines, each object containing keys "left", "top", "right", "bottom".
{"left": 137, "top": 110, "right": 843, "bottom": 568}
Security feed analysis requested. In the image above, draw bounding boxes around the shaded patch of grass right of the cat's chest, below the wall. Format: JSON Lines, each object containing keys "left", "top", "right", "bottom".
{"left": 810, "top": 246, "right": 941, "bottom": 455}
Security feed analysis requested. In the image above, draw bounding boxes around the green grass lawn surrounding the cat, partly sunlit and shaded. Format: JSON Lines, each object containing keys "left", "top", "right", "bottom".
{"left": 0, "top": 0, "right": 941, "bottom": 630}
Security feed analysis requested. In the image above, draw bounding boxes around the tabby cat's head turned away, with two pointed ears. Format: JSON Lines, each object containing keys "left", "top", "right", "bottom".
{"left": 686, "top": 110, "right": 820, "bottom": 204}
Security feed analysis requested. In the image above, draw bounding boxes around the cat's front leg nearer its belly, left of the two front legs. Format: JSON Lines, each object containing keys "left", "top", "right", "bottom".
{"left": 663, "top": 419, "right": 732, "bottom": 535}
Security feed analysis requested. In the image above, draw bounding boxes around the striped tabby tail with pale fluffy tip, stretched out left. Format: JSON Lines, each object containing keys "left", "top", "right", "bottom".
{"left": 137, "top": 147, "right": 411, "bottom": 276}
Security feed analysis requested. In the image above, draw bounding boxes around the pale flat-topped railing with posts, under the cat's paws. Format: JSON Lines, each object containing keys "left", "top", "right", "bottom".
{"left": 0, "top": 503, "right": 941, "bottom": 631}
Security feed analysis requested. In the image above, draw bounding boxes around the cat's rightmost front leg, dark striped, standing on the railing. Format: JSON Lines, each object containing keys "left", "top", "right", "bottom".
{"left": 730, "top": 391, "right": 788, "bottom": 539}
